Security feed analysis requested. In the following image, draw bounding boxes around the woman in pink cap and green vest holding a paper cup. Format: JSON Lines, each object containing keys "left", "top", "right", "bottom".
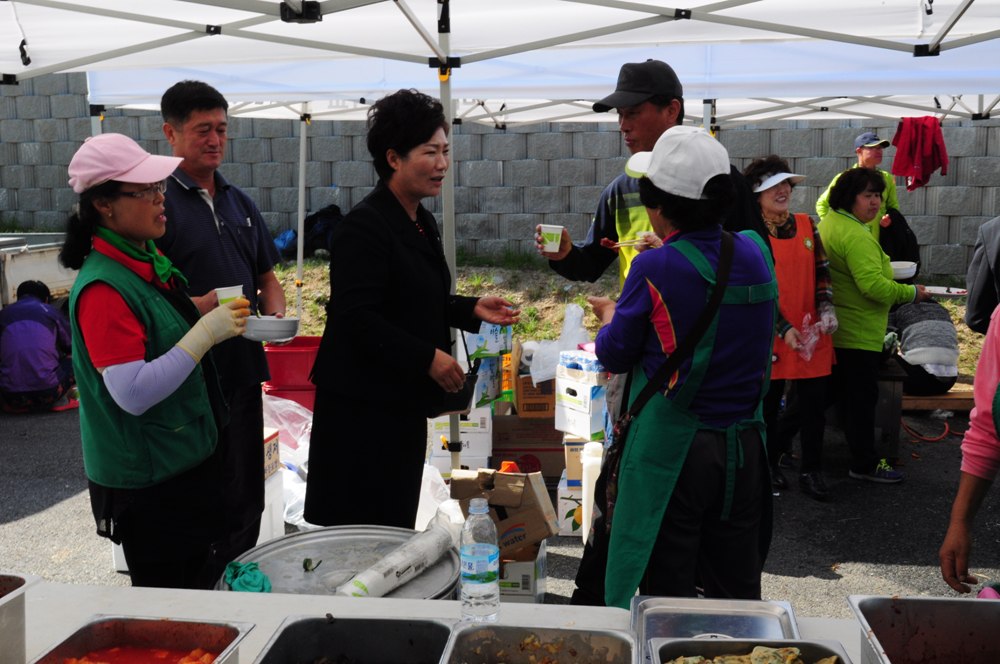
{"left": 59, "top": 134, "right": 250, "bottom": 589}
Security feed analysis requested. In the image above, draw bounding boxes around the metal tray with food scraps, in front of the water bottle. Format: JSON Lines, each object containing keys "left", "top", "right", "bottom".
{"left": 441, "top": 623, "right": 635, "bottom": 664}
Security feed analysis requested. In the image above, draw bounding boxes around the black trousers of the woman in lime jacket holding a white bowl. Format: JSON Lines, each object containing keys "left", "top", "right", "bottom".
{"left": 833, "top": 348, "right": 882, "bottom": 473}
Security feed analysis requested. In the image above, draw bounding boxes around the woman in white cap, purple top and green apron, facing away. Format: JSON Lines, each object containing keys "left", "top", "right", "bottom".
{"left": 574, "top": 127, "right": 777, "bottom": 608}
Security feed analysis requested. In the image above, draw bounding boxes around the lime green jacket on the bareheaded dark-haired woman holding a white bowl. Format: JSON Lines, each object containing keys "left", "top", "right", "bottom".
{"left": 819, "top": 210, "right": 917, "bottom": 351}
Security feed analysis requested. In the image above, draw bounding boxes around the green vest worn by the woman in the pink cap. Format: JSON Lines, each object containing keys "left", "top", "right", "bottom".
{"left": 69, "top": 251, "right": 218, "bottom": 489}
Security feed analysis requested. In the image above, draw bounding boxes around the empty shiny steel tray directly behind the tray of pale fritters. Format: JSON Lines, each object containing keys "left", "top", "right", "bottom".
{"left": 631, "top": 595, "right": 799, "bottom": 662}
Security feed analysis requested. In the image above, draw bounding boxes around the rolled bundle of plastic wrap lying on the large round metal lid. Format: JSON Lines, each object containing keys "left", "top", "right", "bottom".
{"left": 335, "top": 498, "right": 465, "bottom": 597}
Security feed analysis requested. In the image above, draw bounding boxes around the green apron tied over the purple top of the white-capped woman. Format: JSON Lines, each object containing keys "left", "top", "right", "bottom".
{"left": 605, "top": 233, "right": 777, "bottom": 609}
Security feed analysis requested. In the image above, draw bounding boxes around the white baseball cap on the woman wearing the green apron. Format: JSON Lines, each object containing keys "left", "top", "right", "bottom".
{"left": 625, "top": 125, "right": 731, "bottom": 199}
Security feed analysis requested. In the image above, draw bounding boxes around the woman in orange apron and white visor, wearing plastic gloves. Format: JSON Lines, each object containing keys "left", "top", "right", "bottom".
{"left": 743, "top": 155, "right": 837, "bottom": 500}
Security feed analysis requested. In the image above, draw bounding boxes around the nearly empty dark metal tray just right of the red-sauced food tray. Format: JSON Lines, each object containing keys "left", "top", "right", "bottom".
{"left": 254, "top": 614, "right": 451, "bottom": 664}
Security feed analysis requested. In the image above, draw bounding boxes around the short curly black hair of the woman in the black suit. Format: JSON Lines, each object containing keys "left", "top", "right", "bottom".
{"left": 368, "top": 90, "right": 448, "bottom": 180}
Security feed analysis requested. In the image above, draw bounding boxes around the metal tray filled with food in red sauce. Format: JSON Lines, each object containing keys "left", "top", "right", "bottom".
{"left": 31, "top": 615, "right": 253, "bottom": 664}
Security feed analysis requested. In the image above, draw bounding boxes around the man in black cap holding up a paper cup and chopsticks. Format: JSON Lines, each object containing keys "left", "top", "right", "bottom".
{"left": 535, "top": 60, "right": 767, "bottom": 284}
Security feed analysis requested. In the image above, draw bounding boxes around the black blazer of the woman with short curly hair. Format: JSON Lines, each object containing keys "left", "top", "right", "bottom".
{"left": 312, "top": 182, "right": 480, "bottom": 410}
